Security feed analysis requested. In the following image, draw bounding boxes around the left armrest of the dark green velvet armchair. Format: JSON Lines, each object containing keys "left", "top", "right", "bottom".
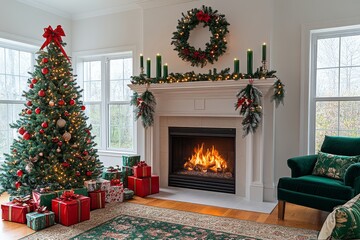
{"left": 287, "top": 155, "right": 317, "bottom": 177}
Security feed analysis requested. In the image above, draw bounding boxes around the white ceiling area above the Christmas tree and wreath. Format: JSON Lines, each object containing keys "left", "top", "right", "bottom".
{"left": 17, "top": 0, "right": 200, "bottom": 20}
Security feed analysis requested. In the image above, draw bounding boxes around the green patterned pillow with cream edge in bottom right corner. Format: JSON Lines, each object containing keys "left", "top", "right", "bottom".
{"left": 318, "top": 194, "right": 360, "bottom": 240}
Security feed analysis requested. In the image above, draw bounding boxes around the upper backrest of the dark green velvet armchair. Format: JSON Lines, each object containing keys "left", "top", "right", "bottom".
{"left": 320, "top": 136, "right": 360, "bottom": 156}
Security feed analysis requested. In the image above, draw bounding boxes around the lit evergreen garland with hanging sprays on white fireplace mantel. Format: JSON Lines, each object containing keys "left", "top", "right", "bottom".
{"left": 130, "top": 68, "right": 285, "bottom": 137}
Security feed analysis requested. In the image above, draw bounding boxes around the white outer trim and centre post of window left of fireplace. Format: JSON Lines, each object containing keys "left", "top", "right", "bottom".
{"left": 72, "top": 46, "right": 139, "bottom": 157}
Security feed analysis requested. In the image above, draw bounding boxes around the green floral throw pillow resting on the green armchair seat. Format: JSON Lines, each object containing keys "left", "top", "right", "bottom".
{"left": 312, "top": 152, "right": 360, "bottom": 180}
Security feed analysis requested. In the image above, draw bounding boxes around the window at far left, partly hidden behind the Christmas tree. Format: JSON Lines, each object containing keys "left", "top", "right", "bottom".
{"left": 0, "top": 39, "right": 35, "bottom": 159}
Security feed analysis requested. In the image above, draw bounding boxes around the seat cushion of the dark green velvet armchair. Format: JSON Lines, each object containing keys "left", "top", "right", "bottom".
{"left": 278, "top": 175, "right": 354, "bottom": 201}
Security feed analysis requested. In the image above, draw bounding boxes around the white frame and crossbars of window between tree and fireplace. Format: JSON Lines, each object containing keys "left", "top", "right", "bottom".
{"left": 74, "top": 48, "right": 138, "bottom": 156}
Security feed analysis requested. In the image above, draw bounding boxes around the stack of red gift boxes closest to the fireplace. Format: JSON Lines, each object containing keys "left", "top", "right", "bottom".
{"left": 128, "top": 161, "right": 159, "bottom": 197}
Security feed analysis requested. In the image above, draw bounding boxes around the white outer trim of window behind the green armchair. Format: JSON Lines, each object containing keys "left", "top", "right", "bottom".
{"left": 299, "top": 22, "right": 360, "bottom": 155}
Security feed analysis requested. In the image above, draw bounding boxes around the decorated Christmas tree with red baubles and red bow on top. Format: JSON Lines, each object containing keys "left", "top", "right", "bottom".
{"left": 0, "top": 26, "right": 103, "bottom": 196}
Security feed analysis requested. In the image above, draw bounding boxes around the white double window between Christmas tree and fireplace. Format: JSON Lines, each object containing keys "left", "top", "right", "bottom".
{"left": 78, "top": 52, "right": 136, "bottom": 152}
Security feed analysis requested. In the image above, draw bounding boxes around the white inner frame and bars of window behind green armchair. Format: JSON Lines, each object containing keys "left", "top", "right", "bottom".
{"left": 307, "top": 25, "right": 360, "bottom": 154}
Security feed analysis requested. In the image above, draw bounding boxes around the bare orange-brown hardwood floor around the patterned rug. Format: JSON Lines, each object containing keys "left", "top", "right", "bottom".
{"left": 0, "top": 194, "right": 328, "bottom": 240}
